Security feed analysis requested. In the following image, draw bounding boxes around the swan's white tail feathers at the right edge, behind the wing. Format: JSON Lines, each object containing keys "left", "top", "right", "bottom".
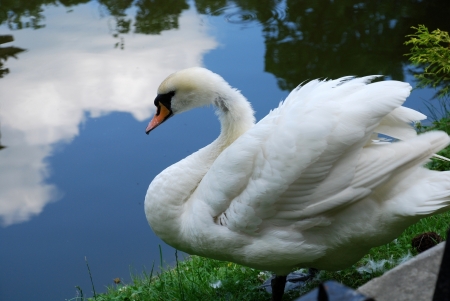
{"left": 368, "top": 131, "right": 450, "bottom": 218}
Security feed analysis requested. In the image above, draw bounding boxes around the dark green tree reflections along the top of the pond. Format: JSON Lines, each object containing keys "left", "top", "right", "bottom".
{"left": 0, "top": 0, "right": 450, "bottom": 90}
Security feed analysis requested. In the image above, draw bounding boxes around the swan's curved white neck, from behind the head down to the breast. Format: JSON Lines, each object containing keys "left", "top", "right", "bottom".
{"left": 145, "top": 88, "right": 255, "bottom": 246}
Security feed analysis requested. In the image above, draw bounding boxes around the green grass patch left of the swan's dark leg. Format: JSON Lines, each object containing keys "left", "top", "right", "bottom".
{"left": 70, "top": 248, "right": 267, "bottom": 301}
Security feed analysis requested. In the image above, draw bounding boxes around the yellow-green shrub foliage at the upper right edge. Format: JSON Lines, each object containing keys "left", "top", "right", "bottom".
{"left": 405, "top": 25, "right": 450, "bottom": 98}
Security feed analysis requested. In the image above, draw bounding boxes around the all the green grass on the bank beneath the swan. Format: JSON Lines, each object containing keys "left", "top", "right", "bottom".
{"left": 69, "top": 212, "right": 450, "bottom": 301}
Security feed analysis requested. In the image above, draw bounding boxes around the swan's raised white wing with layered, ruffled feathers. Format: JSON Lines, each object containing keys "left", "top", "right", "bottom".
{"left": 193, "top": 77, "right": 440, "bottom": 233}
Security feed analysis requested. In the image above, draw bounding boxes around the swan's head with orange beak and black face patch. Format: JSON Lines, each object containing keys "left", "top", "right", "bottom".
{"left": 145, "top": 67, "right": 231, "bottom": 134}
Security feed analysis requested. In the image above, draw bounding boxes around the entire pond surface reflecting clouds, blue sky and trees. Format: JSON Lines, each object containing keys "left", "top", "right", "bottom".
{"left": 0, "top": 0, "right": 450, "bottom": 300}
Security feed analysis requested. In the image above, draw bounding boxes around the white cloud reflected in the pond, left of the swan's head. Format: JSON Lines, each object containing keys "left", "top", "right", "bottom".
{"left": 0, "top": 5, "right": 217, "bottom": 226}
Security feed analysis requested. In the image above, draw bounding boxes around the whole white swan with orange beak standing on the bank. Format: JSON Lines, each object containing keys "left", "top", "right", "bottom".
{"left": 145, "top": 67, "right": 450, "bottom": 300}
